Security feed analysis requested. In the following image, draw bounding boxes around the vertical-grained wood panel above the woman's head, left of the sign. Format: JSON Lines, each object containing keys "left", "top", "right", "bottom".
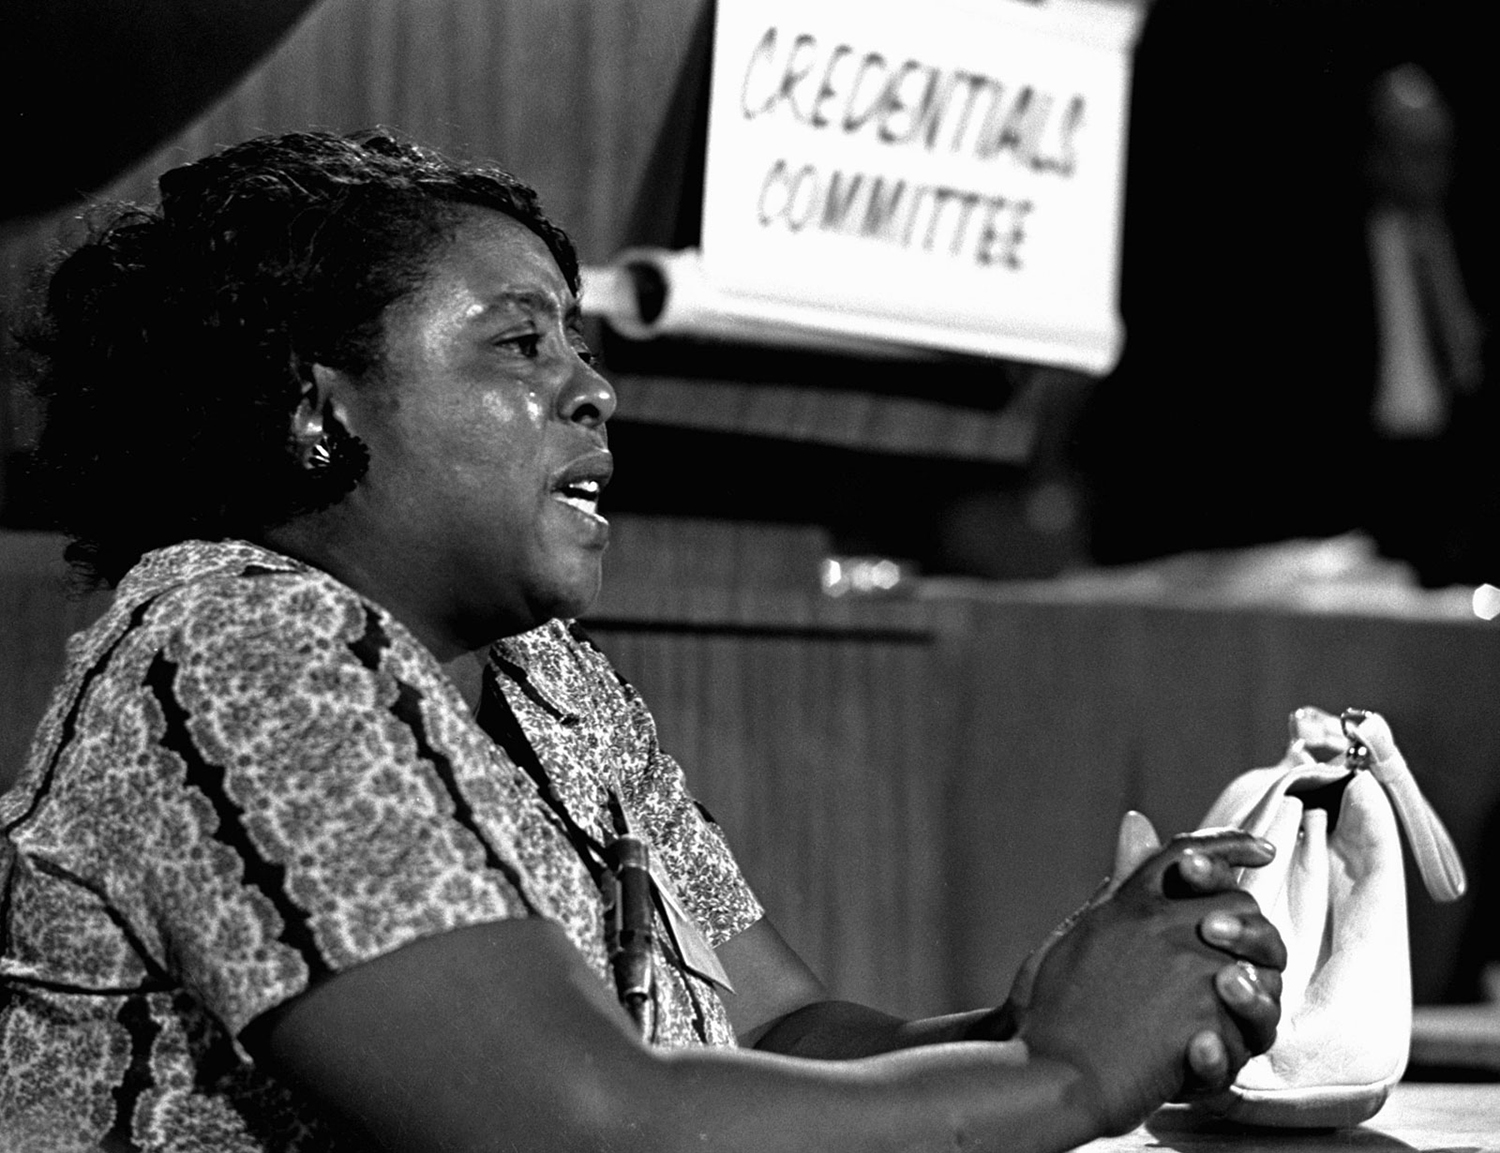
{"left": 0, "top": 0, "right": 707, "bottom": 467}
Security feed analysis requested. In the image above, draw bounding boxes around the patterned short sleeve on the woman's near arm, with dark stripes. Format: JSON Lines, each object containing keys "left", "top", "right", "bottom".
{"left": 120, "top": 574, "right": 528, "bottom": 1035}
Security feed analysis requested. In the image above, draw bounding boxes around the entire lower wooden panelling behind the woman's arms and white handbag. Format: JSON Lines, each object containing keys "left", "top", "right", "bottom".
{"left": 0, "top": 525, "right": 1500, "bottom": 1014}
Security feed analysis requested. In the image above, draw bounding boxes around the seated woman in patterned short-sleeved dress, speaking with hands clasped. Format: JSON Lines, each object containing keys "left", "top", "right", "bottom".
{"left": 0, "top": 135, "right": 1284, "bottom": 1153}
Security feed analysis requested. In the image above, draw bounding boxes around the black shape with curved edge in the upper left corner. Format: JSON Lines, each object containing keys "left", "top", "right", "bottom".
{"left": 0, "top": 0, "right": 320, "bottom": 515}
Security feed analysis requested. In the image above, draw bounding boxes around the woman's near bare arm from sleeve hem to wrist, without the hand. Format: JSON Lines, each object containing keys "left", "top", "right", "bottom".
{"left": 245, "top": 918, "right": 1098, "bottom": 1153}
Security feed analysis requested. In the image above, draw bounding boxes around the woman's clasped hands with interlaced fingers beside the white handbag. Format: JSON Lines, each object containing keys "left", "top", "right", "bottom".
{"left": 1005, "top": 813, "right": 1287, "bottom": 1132}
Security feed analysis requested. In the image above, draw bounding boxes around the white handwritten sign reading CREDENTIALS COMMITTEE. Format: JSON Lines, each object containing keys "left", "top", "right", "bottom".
{"left": 702, "top": 0, "right": 1142, "bottom": 372}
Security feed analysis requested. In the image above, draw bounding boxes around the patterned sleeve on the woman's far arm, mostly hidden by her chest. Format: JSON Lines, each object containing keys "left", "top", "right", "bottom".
{"left": 612, "top": 674, "right": 764, "bottom": 948}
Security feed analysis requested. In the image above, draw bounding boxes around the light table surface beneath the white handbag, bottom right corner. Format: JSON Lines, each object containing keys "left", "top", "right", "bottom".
{"left": 1083, "top": 1083, "right": 1500, "bottom": 1153}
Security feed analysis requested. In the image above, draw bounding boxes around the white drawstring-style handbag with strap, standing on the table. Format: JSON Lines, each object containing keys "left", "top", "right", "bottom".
{"left": 1202, "top": 709, "right": 1466, "bottom": 1128}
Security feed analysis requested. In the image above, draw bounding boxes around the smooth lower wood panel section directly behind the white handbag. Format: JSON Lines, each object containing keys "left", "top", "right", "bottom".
{"left": 945, "top": 592, "right": 1500, "bottom": 1003}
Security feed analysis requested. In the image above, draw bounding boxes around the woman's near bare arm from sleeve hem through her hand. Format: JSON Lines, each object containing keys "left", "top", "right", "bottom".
{"left": 245, "top": 827, "right": 1278, "bottom": 1153}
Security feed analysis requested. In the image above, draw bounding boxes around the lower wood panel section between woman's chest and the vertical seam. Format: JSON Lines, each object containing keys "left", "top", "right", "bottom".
{"left": 593, "top": 627, "right": 951, "bottom": 1014}
